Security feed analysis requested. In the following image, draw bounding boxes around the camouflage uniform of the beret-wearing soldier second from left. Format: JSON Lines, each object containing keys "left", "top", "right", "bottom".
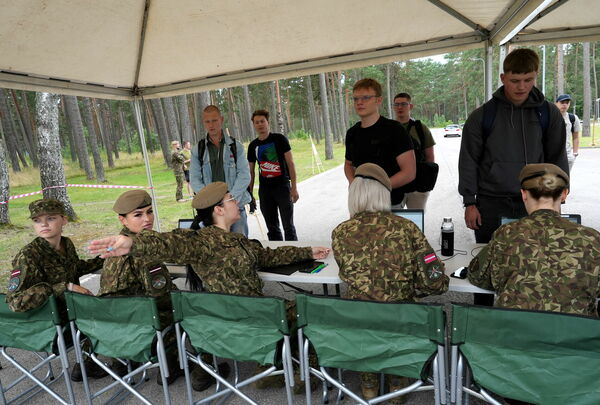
{"left": 98, "top": 228, "right": 177, "bottom": 328}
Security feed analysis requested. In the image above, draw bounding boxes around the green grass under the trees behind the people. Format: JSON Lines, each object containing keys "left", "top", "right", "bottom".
{"left": 0, "top": 140, "right": 344, "bottom": 292}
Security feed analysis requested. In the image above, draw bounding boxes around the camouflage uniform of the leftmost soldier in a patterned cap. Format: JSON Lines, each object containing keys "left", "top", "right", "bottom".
{"left": 6, "top": 236, "right": 104, "bottom": 321}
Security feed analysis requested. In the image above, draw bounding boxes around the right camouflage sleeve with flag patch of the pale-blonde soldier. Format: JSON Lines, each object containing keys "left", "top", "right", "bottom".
{"left": 410, "top": 224, "right": 449, "bottom": 295}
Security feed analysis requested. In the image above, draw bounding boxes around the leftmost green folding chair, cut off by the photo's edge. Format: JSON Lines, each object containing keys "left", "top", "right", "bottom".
{"left": 0, "top": 294, "right": 75, "bottom": 405}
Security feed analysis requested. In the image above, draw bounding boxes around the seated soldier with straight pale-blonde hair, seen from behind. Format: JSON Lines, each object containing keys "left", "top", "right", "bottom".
{"left": 331, "top": 163, "right": 448, "bottom": 404}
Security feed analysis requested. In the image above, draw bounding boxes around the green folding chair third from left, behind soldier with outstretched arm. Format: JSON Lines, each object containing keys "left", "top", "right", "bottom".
{"left": 171, "top": 291, "right": 294, "bottom": 405}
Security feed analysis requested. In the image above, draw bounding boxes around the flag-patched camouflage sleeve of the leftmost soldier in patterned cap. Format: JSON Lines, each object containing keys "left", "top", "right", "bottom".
{"left": 6, "top": 251, "right": 56, "bottom": 312}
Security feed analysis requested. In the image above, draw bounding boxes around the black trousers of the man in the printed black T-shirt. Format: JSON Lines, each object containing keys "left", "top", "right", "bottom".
{"left": 258, "top": 182, "right": 298, "bottom": 240}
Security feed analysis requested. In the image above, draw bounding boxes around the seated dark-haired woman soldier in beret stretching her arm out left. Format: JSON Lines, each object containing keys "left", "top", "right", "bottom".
{"left": 89, "top": 182, "right": 329, "bottom": 392}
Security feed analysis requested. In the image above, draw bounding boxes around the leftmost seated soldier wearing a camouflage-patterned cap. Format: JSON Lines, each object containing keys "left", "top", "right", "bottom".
{"left": 6, "top": 199, "right": 107, "bottom": 381}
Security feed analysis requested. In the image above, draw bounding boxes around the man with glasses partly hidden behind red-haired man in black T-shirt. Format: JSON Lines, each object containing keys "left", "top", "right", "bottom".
{"left": 393, "top": 93, "right": 435, "bottom": 210}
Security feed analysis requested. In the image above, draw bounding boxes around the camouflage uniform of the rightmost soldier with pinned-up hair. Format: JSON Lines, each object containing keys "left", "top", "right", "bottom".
{"left": 469, "top": 209, "right": 600, "bottom": 316}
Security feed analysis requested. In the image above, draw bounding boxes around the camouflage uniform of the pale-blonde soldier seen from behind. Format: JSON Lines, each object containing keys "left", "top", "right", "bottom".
{"left": 331, "top": 211, "right": 449, "bottom": 389}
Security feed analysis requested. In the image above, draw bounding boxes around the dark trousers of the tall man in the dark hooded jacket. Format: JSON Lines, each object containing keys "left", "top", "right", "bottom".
{"left": 473, "top": 195, "right": 527, "bottom": 307}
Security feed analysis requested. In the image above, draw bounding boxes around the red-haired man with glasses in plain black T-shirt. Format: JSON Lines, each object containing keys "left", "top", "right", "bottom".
{"left": 344, "top": 79, "right": 416, "bottom": 208}
